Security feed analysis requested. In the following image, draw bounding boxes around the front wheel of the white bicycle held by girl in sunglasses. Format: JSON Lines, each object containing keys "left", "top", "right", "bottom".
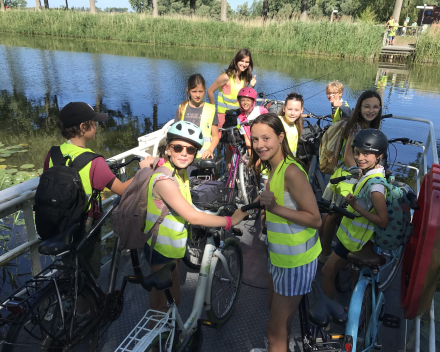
{"left": 206, "top": 238, "right": 243, "bottom": 325}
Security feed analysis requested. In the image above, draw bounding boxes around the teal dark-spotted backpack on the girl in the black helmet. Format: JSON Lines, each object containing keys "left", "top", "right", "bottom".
{"left": 362, "top": 178, "right": 414, "bottom": 250}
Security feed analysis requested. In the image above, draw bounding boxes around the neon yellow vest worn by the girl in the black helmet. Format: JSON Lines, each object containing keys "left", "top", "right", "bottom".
{"left": 336, "top": 173, "right": 383, "bottom": 252}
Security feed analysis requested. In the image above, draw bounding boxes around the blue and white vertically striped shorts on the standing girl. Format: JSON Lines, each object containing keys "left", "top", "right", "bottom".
{"left": 268, "top": 255, "right": 318, "bottom": 297}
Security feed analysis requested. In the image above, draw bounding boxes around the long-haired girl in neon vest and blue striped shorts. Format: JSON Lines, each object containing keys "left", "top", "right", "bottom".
{"left": 250, "top": 113, "right": 321, "bottom": 352}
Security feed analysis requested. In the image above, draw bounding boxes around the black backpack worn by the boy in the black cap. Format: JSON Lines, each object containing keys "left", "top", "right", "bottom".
{"left": 34, "top": 146, "right": 101, "bottom": 241}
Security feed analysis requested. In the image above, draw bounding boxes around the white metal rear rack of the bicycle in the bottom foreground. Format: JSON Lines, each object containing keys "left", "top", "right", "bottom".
{"left": 115, "top": 309, "right": 171, "bottom": 352}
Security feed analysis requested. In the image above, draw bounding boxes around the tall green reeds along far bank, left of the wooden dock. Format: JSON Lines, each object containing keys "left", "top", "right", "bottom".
{"left": 0, "top": 11, "right": 383, "bottom": 58}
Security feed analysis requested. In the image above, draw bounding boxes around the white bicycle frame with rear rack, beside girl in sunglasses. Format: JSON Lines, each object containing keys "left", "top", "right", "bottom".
{"left": 116, "top": 236, "right": 233, "bottom": 352}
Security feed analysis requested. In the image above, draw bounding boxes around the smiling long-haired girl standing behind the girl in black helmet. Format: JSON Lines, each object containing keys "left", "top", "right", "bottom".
{"left": 319, "top": 90, "right": 382, "bottom": 264}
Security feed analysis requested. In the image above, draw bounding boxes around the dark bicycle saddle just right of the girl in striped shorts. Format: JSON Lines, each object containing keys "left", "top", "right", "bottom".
{"left": 309, "top": 281, "right": 348, "bottom": 328}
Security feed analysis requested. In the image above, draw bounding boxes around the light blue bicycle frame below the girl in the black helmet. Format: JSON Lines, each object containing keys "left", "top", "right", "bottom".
{"left": 345, "top": 268, "right": 385, "bottom": 351}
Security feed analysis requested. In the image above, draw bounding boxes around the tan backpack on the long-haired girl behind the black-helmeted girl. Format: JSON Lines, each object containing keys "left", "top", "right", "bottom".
{"left": 319, "top": 118, "right": 349, "bottom": 175}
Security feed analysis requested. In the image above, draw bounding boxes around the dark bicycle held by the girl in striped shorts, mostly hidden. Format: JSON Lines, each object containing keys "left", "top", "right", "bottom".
{"left": 241, "top": 201, "right": 354, "bottom": 352}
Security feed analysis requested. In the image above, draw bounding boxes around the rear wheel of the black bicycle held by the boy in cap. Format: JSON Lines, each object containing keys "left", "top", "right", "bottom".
{"left": 2, "top": 282, "right": 98, "bottom": 352}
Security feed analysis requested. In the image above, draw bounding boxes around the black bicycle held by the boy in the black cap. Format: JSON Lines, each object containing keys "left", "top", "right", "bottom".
{"left": 0, "top": 157, "right": 148, "bottom": 352}
